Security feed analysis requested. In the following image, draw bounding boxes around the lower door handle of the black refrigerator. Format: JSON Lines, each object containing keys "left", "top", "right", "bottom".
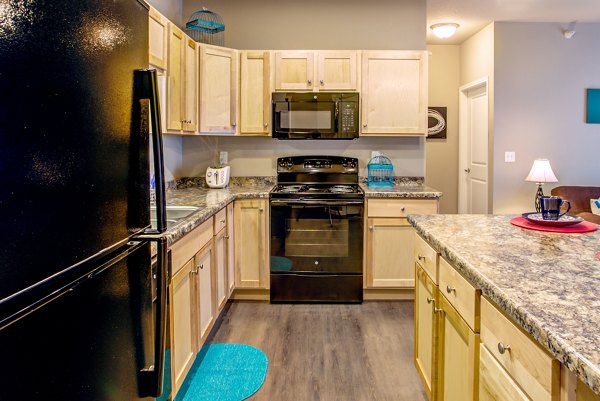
{"left": 134, "top": 234, "right": 168, "bottom": 397}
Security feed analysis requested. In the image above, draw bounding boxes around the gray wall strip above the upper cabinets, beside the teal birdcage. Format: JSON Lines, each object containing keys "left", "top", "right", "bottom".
{"left": 183, "top": 0, "right": 426, "bottom": 50}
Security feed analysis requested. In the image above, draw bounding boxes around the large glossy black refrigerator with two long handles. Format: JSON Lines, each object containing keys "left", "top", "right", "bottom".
{"left": 0, "top": 0, "right": 167, "bottom": 401}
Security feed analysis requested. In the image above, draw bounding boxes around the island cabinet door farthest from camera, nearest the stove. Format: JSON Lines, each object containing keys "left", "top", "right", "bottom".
{"left": 414, "top": 264, "right": 437, "bottom": 400}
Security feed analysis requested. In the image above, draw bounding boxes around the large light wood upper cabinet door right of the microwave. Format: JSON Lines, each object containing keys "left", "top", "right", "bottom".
{"left": 361, "top": 51, "right": 427, "bottom": 135}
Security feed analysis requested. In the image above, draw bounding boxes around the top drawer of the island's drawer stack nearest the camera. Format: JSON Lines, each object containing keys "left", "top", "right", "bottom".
{"left": 481, "top": 298, "right": 560, "bottom": 401}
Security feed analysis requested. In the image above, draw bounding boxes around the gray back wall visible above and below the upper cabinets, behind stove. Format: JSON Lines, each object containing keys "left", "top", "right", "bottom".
{"left": 176, "top": 0, "right": 426, "bottom": 177}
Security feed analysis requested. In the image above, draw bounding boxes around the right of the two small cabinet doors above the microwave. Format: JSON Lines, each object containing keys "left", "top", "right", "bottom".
{"left": 315, "top": 50, "right": 357, "bottom": 91}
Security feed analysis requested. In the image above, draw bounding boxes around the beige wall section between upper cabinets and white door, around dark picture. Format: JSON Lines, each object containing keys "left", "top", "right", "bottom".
{"left": 425, "top": 45, "right": 460, "bottom": 213}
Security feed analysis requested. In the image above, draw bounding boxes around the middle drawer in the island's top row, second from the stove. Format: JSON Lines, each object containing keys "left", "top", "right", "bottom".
{"left": 439, "top": 258, "right": 481, "bottom": 333}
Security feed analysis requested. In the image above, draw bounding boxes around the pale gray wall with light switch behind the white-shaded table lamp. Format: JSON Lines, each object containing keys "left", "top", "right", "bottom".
{"left": 494, "top": 22, "right": 600, "bottom": 213}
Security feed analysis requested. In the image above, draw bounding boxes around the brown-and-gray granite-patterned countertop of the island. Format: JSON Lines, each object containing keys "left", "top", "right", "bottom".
{"left": 408, "top": 215, "right": 600, "bottom": 395}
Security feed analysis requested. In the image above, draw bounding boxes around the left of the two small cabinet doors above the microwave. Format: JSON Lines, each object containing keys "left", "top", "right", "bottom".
{"left": 275, "top": 50, "right": 315, "bottom": 91}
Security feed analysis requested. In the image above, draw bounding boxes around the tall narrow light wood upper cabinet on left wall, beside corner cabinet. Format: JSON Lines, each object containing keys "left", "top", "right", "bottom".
{"left": 167, "top": 24, "right": 198, "bottom": 133}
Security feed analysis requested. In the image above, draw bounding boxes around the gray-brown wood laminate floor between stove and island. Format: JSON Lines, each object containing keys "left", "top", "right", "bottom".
{"left": 208, "top": 302, "right": 427, "bottom": 401}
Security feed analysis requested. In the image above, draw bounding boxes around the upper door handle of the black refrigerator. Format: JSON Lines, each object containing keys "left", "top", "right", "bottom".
{"left": 135, "top": 70, "right": 167, "bottom": 233}
